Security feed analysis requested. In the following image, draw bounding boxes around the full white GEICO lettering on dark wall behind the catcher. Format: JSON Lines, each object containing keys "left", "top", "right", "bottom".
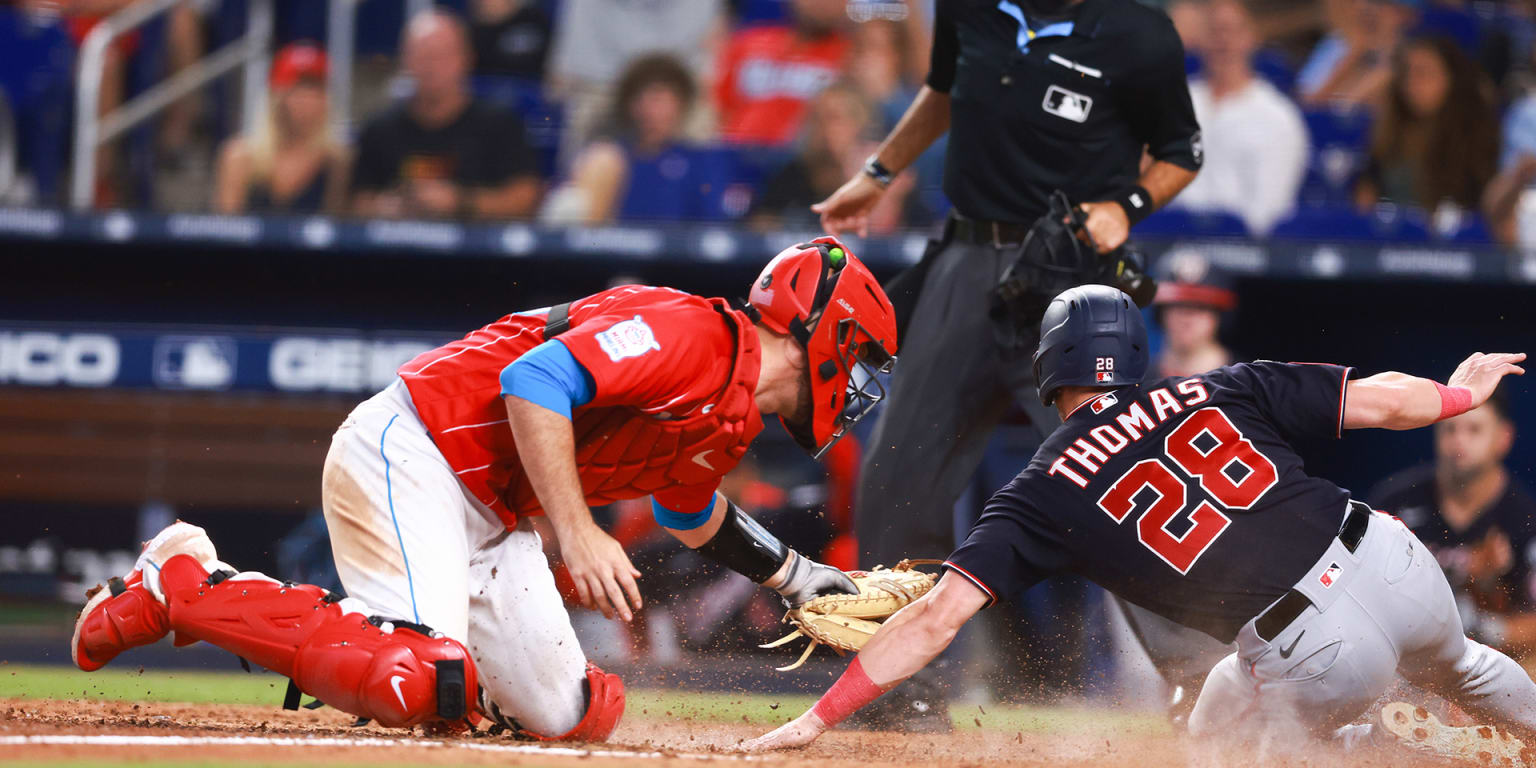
{"left": 267, "top": 336, "right": 432, "bottom": 392}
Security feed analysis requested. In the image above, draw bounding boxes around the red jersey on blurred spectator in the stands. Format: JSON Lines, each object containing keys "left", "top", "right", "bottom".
{"left": 714, "top": 26, "right": 848, "bottom": 144}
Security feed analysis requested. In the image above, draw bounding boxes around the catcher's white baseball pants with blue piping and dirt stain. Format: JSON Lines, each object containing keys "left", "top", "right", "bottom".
{"left": 323, "top": 379, "right": 587, "bottom": 736}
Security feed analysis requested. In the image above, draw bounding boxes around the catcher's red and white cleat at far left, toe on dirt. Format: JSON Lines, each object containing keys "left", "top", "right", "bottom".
{"left": 69, "top": 521, "right": 217, "bottom": 671}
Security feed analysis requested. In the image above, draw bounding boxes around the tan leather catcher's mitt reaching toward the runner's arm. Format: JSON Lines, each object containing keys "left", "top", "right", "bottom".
{"left": 760, "top": 561, "right": 943, "bottom": 671}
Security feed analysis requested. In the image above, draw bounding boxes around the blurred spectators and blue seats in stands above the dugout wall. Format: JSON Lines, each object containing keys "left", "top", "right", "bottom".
{"left": 9, "top": 0, "right": 1536, "bottom": 244}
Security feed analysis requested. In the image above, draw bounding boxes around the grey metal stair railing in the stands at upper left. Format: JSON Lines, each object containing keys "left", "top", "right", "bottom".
{"left": 69, "top": 0, "right": 276, "bottom": 209}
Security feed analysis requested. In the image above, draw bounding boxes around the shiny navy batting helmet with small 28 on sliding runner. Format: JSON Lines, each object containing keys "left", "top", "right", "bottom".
{"left": 1035, "top": 286, "right": 1149, "bottom": 406}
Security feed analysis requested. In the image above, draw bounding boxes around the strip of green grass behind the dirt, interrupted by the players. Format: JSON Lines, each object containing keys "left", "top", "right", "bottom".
{"left": 0, "top": 664, "right": 1167, "bottom": 731}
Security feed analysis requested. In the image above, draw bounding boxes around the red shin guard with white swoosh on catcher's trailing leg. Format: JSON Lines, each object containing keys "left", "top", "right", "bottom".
{"left": 160, "top": 554, "right": 476, "bottom": 728}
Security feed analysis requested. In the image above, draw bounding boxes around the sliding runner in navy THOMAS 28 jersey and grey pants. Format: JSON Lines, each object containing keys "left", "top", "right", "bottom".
{"left": 746, "top": 286, "right": 1536, "bottom": 757}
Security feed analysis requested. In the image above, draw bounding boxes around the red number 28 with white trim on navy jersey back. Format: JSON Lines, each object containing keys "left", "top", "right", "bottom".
{"left": 1098, "top": 409, "right": 1279, "bottom": 573}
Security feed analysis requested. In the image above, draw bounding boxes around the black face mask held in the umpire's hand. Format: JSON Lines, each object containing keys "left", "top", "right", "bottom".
{"left": 989, "top": 190, "right": 1157, "bottom": 355}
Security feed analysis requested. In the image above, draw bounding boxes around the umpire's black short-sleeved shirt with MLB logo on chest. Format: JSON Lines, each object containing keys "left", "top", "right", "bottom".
{"left": 928, "top": 0, "right": 1201, "bottom": 223}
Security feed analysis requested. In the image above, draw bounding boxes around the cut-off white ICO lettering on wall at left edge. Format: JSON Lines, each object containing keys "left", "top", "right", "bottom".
{"left": 0, "top": 332, "right": 121, "bottom": 387}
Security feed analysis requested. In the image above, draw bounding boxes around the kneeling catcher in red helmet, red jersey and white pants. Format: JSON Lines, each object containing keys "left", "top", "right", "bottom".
{"left": 71, "top": 238, "right": 895, "bottom": 740}
